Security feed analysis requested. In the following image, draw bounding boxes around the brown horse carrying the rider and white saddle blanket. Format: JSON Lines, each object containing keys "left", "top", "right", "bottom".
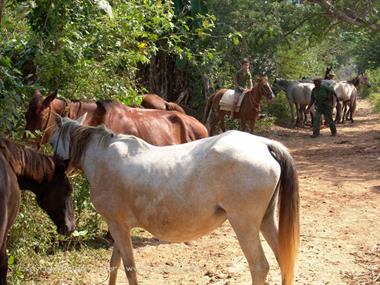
{"left": 203, "top": 76, "right": 275, "bottom": 135}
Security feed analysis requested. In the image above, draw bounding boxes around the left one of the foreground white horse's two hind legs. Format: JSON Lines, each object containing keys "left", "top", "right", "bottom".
{"left": 228, "top": 216, "right": 269, "bottom": 285}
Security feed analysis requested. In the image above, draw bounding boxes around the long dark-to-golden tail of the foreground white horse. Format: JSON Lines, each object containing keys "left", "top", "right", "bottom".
{"left": 268, "top": 143, "right": 300, "bottom": 285}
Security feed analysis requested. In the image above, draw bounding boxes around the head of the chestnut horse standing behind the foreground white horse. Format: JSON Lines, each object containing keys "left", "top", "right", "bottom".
{"left": 25, "top": 91, "right": 57, "bottom": 143}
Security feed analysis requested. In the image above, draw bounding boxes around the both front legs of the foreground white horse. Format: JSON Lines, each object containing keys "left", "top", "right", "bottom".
{"left": 108, "top": 221, "right": 137, "bottom": 285}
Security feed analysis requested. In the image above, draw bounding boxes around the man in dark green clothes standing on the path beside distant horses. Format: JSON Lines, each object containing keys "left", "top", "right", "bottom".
{"left": 305, "top": 78, "right": 336, "bottom": 138}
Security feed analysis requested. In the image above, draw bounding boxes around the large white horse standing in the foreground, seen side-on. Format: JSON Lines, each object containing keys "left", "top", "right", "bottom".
{"left": 51, "top": 117, "right": 299, "bottom": 285}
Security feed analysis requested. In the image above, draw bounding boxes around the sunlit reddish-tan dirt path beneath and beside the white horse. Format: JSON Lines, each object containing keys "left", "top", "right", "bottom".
{"left": 95, "top": 96, "right": 380, "bottom": 285}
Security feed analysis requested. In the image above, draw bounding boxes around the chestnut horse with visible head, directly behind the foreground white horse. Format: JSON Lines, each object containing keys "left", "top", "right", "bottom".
{"left": 25, "top": 91, "right": 208, "bottom": 145}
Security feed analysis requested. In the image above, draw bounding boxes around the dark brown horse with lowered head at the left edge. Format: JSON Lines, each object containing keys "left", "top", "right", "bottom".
{"left": 0, "top": 138, "right": 75, "bottom": 285}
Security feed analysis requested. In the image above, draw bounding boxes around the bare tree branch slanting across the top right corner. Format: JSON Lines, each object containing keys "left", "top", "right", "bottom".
{"left": 307, "top": 0, "right": 380, "bottom": 32}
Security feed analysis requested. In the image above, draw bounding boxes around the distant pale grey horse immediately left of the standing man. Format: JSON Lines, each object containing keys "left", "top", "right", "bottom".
{"left": 273, "top": 78, "right": 314, "bottom": 126}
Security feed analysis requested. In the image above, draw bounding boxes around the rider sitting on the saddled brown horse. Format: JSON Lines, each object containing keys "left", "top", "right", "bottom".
{"left": 230, "top": 58, "right": 253, "bottom": 119}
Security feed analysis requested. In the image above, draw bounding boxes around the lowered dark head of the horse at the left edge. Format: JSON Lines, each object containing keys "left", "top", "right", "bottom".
{"left": 36, "top": 158, "right": 75, "bottom": 235}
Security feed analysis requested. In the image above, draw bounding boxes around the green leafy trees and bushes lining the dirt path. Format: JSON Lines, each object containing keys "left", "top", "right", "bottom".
{"left": 0, "top": 0, "right": 380, "bottom": 285}
